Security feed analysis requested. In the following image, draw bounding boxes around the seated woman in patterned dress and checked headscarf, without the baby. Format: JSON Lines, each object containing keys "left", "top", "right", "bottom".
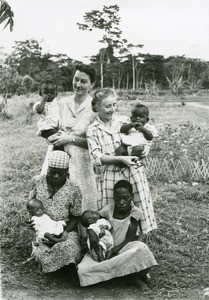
{"left": 29, "top": 150, "right": 82, "bottom": 273}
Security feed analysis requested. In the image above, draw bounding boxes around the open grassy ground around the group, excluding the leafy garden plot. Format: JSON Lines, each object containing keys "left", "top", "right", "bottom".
{"left": 0, "top": 96, "right": 209, "bottom": 298}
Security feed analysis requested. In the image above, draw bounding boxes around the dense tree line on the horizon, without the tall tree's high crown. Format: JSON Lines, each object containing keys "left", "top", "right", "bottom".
{"left": 0, "top": 39, "right": 209, "bottom": 95}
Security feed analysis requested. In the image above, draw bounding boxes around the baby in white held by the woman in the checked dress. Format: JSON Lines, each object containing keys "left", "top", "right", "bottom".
{"left": 115, "top": 104, "right": 158, "bottom": 158}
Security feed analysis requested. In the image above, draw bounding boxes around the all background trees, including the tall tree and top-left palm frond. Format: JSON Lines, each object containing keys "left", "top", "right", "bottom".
{"left": 0, "top": 0, "right": 209, "bottom": 96}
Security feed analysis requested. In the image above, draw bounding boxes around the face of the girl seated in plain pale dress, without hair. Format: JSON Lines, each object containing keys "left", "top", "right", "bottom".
{"left": 114, "top": 187, "right": 133, "bottom": 213}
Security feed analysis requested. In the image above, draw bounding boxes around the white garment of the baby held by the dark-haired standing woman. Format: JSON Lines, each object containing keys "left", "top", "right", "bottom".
{"left": 33, "top": 99, "right": 60, "bottom": 136}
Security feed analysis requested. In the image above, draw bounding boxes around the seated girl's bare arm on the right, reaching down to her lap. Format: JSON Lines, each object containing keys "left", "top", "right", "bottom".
{"left": 105, "top": 217, "right": 139, "bottom": 259}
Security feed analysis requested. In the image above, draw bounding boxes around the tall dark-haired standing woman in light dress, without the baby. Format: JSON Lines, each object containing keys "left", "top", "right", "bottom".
{"left": 42, "top": 65, "right": 97, "bottom": 211}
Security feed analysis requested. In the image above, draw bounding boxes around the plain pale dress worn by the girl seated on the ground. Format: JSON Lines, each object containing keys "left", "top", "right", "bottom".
{"left": 77, "top": 205, "right": 157, "bottom": 286}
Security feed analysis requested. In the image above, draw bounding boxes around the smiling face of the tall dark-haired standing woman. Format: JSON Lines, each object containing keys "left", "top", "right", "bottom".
{"left": 73, "top": 70, "right": 93, "bottom": 96}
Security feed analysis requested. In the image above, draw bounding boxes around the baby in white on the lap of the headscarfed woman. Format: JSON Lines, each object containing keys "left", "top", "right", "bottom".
{"left": 26, "top": 199, "right": 66, "bottom": 243}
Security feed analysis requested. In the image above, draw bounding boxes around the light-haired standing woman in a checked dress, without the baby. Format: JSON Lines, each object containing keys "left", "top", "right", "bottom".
{"left": 87, "top": 88, "right": 157, "bottom": 234}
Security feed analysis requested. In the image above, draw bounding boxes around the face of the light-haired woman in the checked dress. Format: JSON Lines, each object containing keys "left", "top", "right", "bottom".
{"left": 98, "top": 96, "right": 117, "bottom": 123}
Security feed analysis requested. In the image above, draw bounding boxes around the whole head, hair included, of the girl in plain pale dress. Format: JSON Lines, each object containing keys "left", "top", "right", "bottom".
{"left": 114, "top": 180, "right": 133, "bottom": 213}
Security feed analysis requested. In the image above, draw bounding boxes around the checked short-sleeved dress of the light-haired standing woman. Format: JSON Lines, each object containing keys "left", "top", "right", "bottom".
{"left": 87, "top": 115, "right": 157, "bottom": 234}
